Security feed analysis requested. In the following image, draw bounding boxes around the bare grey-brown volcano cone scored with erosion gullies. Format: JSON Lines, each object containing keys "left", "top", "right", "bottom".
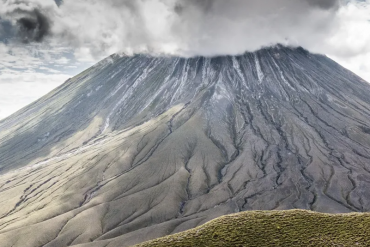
{"left": 0, "top": 46, "right": 370, "bottom": 247}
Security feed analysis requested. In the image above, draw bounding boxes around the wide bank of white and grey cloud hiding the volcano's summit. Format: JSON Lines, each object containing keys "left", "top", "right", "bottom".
{"left": 0, "top": 0, "right": 368, "bottom": 57}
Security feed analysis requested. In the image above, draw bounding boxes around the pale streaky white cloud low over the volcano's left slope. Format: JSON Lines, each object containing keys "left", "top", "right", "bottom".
{"left": 0, "top": 43, "right": 89, "bottom": 120}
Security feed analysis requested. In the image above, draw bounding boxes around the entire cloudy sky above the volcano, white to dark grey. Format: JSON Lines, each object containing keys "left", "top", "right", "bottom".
{"left": 0, "top": 0, "right": 370, "bottom": 119}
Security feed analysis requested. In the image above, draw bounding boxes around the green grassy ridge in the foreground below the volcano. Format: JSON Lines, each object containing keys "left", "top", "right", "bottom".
{"left": 135, "top": 210, "right": 370, "bottom": 247}
